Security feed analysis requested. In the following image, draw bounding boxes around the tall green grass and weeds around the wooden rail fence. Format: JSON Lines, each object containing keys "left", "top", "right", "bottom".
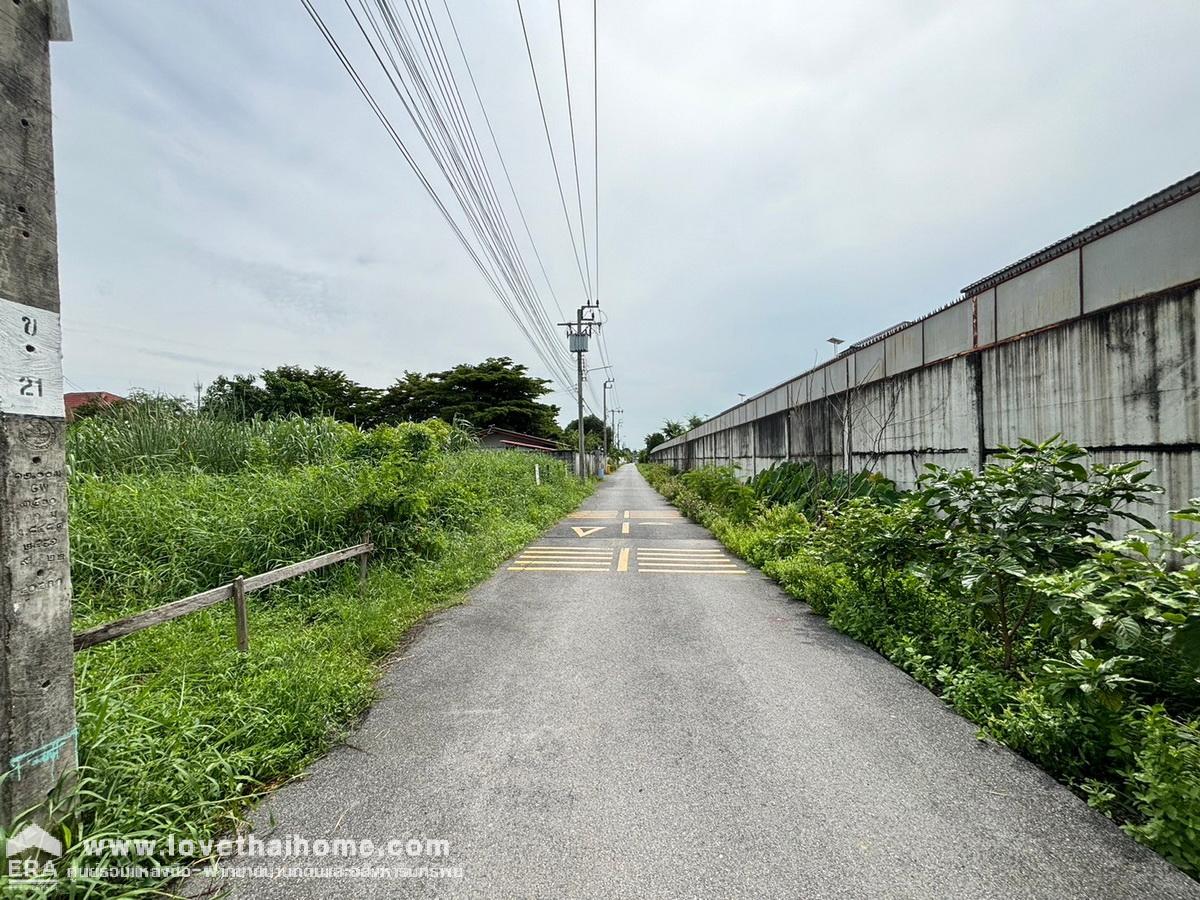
{"left": 4, "top": 416, "right": 592, "bottom": 896}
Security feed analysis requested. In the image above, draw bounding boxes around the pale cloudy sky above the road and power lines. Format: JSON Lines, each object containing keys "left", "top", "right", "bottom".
{"left": 52, "top": 0, "right": 1200, "bottom": 446}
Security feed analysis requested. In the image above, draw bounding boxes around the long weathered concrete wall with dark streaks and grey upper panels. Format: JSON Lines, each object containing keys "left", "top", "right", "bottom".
{"left": 653, "top": 174, "right": 1200, "bottom": 532}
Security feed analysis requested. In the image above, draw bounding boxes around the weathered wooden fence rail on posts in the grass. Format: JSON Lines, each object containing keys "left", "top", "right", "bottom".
{"left": 74, "top": 534, "right": 374, "bottom": 653}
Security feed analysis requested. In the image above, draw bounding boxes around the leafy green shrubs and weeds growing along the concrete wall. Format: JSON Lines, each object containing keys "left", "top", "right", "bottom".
{"left": 640, "top": 439, "right": 1200, "bottom": 878}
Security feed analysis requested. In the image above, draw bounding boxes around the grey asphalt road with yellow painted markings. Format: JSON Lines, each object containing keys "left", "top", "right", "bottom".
{"left": 206, "top": 467, "right": 1200, "bottom": 900}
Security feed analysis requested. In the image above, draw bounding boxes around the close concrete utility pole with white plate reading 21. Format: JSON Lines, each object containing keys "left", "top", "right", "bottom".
{"left": 0, "top": 0, "right": 78, "bottom": 829}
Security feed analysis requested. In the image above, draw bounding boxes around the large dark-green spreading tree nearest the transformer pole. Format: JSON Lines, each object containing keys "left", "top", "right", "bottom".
{"left": 377, "top": 356, "right": 560, "bottom": 438}
